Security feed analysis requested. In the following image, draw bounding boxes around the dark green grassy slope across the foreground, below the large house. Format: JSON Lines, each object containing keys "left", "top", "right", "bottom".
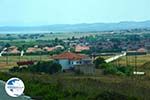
{"left": 0, "top": 73, "right": 150, "bottom": 100}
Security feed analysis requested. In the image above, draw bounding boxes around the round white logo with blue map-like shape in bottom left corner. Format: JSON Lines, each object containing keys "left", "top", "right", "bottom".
{"left": 5, "top": 78, "right": 25, "bottom": 97}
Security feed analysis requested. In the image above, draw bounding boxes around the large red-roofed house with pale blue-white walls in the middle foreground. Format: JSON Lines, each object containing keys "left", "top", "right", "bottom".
{"left": 53, "top": 52, "right": 92, "bottom": 70}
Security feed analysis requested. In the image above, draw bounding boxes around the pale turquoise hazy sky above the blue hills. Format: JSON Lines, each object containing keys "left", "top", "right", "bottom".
{"left": 0, "top": 0, "right": 150, "bottom": 26}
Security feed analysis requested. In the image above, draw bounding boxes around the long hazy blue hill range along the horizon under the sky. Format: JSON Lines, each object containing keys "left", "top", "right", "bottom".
{"left": 0, "top": 21, "right": 150, "bottom": 32}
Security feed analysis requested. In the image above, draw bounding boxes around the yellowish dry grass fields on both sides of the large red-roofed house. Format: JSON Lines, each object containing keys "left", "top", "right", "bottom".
{"left": 0, "top": 54, "right": 150, "bottom": 70}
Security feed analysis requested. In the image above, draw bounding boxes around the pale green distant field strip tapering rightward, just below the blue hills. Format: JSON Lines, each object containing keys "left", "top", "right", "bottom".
{"left": 0, "top": 32, "right": 99, "bottom": 42}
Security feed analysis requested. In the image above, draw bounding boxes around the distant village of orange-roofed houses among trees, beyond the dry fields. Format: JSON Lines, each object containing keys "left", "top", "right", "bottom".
{"left": 0, "top": 30, "right": 150, "bottom": 55}
